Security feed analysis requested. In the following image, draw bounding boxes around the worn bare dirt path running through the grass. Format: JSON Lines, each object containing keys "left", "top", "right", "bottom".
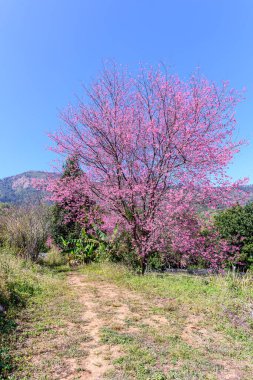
{"left": 67, "top": 274, "right": 149, "bottom": 380}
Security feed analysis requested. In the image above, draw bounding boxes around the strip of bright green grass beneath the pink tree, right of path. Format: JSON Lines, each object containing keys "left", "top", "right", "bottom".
{"left": 81, "top": 264, "right": 253, "bottom": 316}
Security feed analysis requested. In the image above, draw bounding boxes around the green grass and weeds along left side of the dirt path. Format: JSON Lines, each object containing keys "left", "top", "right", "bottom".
{"left": 0, "top": 251, "right": 76, "bottom": 379}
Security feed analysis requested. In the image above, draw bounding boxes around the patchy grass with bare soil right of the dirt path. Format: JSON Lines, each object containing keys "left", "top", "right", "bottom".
{"left": 81, "top": 264, "right": 253, "bottom": 380}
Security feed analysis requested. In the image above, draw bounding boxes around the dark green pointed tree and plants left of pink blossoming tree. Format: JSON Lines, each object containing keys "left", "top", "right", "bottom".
{"left": 47, "top": 154, "right": 106, "bottom": 264}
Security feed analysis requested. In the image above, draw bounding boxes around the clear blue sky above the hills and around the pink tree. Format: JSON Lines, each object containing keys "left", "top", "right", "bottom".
{"left": 0, "top": 0, "right": 253, "bottom": 183}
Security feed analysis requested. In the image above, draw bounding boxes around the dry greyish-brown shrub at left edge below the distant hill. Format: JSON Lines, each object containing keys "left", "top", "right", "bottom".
{"left": 0, "top": 204, "right": 50, "bottom": 260}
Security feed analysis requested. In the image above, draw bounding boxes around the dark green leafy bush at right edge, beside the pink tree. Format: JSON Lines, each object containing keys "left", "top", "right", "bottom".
{"left": 215, "top": 203, "right": 253, "bottom": 269}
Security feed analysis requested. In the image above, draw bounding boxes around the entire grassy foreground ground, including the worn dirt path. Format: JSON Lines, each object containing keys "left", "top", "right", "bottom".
{"left": 0, "top": 253, "right": 253, "bottom": 380}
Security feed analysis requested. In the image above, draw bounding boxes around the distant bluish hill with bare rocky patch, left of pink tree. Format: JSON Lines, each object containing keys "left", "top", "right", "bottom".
{"left": 0, "top": 171, "right": 57, "bottom": 204}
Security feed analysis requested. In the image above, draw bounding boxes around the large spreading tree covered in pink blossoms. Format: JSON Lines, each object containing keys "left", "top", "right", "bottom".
{"left": 48, "top": 66, "right": 245, "bottom": 273}
